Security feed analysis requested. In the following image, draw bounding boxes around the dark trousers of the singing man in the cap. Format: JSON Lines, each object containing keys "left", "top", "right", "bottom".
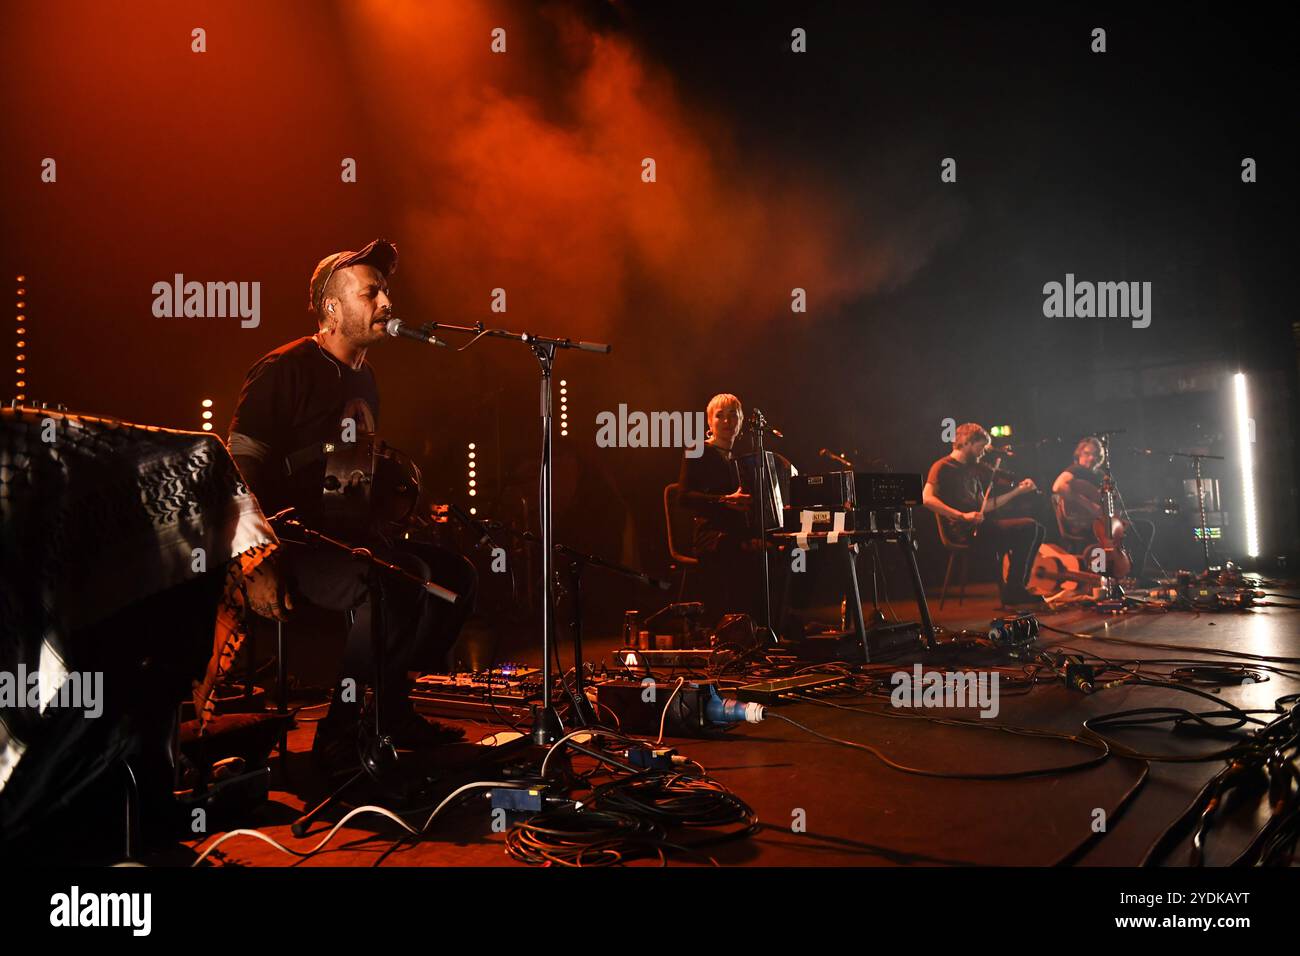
{"left": 283, "top": 540, "right": 478, "bottom": 723}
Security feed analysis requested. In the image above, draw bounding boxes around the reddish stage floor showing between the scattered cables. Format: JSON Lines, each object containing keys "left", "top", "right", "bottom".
{"left": 165, "top": 585, "right": 1300, "bottom": 866}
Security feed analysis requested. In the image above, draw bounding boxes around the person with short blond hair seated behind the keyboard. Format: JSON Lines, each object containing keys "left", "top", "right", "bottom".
{"left": 677, "top": 393, "right": 763, "bottom": 620}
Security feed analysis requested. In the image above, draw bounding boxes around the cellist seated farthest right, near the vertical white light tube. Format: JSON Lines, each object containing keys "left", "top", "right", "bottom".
{"left": 1052, "top": 436, "right": 1156, "bottom": 578}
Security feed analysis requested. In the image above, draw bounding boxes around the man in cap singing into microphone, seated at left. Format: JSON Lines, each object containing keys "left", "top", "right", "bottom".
{"left": 229, "top": 239, "right": 476, "bottom": 773}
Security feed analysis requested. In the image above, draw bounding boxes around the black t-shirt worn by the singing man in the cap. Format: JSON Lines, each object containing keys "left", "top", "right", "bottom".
{"left": 230, "top": 336, "right": 380, "bottom": 514}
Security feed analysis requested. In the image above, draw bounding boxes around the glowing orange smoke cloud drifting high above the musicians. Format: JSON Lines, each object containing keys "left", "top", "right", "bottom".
{"left": 343, "top": 3, "right": 930, "bottom": 337}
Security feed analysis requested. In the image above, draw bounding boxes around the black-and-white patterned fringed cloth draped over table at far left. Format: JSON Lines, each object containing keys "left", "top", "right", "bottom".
{"left": 0, "top": 408, "right": 278, "bottom": 792}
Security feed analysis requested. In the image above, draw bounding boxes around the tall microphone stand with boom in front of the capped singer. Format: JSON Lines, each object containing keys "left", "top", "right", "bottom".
{"left": 408, "top": 323, "right": 610, "bottom": 747}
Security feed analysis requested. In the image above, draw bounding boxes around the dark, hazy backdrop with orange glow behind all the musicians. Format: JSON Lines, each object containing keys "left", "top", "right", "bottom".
{"left": 0, "top": 1, "right": 1297, "bottom": 628}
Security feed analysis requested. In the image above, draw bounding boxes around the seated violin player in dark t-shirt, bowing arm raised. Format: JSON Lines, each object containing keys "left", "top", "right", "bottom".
{"left": 922, "top": 421, "right": 1047, "bottom": 605}
